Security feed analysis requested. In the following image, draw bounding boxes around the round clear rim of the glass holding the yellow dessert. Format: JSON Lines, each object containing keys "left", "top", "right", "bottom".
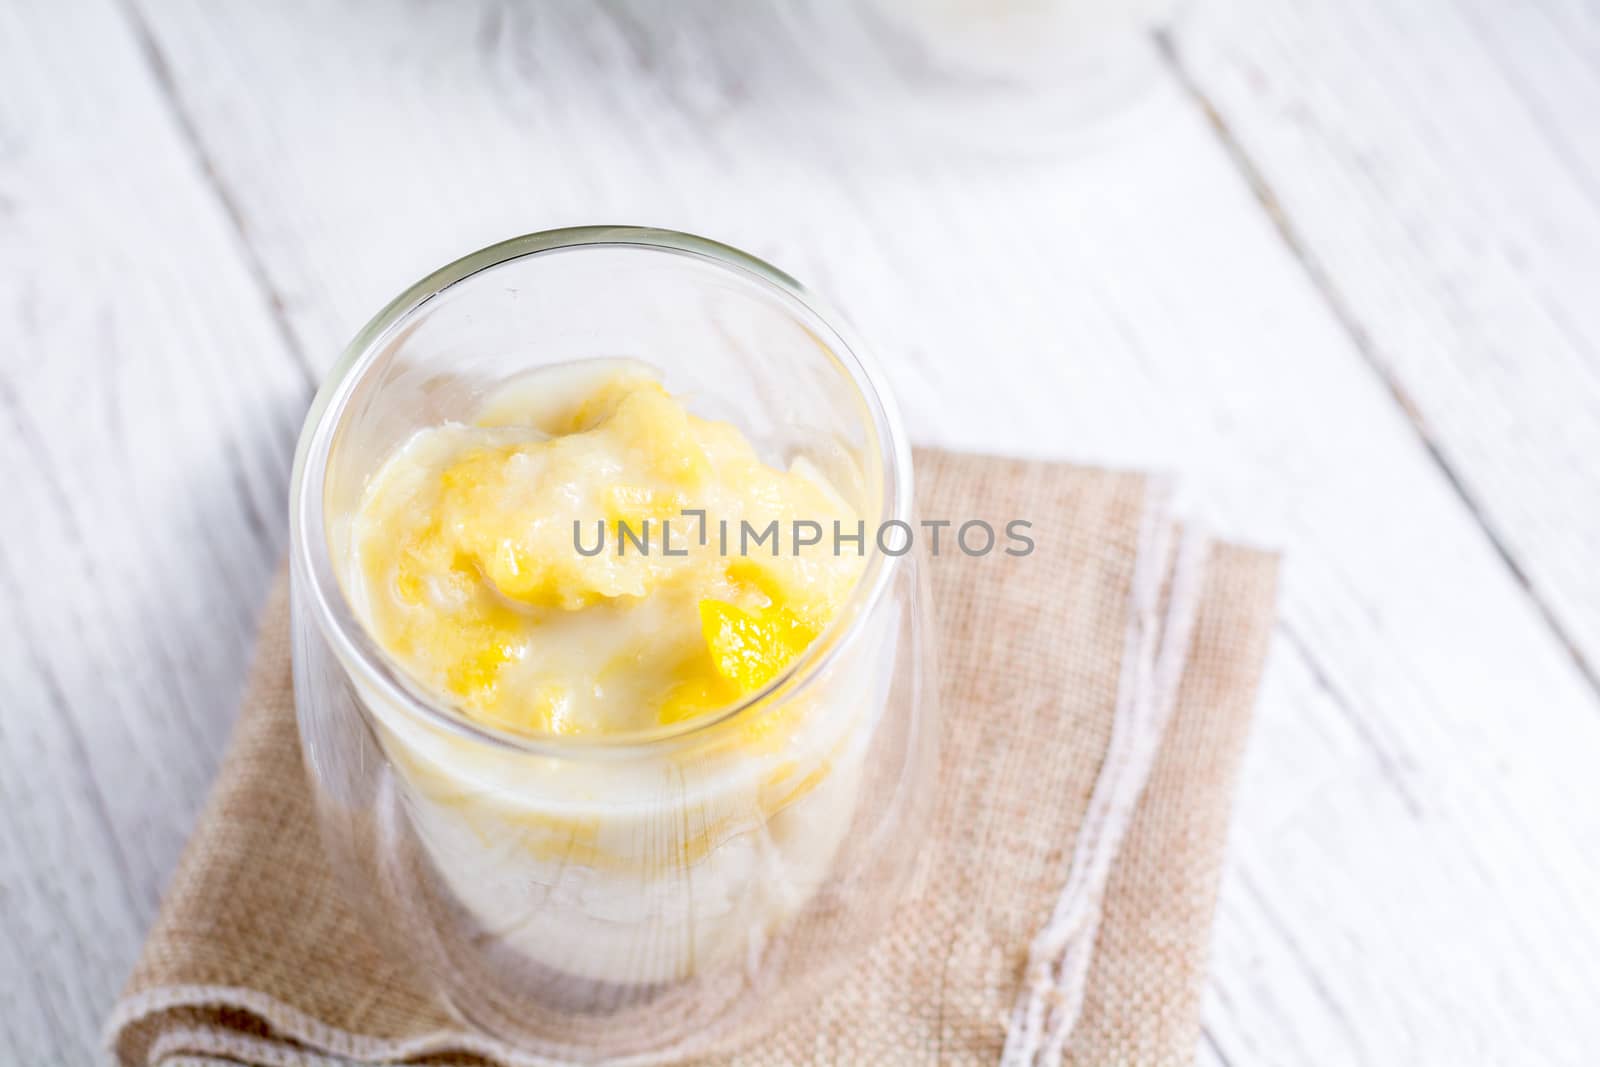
{"left": 288, "top": 226, "right": 912, "bottom": 758}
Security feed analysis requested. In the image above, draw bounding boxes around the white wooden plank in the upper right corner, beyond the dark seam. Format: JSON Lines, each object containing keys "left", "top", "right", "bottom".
{"left": 1176, "top": 0, "right": 1600, "bottom": 685}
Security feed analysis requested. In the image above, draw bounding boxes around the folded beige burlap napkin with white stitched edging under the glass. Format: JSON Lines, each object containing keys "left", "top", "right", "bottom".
{"left": 107, "top": 451, "right": 1275, "bottom": 1067}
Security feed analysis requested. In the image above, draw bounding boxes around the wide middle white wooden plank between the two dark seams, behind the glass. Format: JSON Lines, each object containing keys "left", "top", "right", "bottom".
{"left": 128, "top": 3, "right": 1600, "bottom": 1064}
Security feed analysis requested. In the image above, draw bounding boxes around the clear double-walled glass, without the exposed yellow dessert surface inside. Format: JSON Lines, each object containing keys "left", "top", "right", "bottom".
{"left": 290, "top": 227, "right": 938, "bottom": 1061}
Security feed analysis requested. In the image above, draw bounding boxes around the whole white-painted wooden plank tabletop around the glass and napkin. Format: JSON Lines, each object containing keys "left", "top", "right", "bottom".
{"left": 0, "top": 0, "right": 1600, "bottom": 1067}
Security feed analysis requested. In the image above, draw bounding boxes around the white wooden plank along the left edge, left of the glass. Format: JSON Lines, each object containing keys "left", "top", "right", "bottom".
{"left": 0, "top": 0, "right": 307, "bottom": 1064}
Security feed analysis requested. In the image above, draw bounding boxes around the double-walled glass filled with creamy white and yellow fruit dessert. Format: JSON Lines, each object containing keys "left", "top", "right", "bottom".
{"left": 290, "top": 227, "right": 938, "bottom": 1059}
